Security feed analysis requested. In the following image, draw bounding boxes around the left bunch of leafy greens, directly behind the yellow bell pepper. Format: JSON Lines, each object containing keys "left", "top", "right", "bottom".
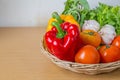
{"left": 62, "top": 0, "right": 90, "bottom": 24}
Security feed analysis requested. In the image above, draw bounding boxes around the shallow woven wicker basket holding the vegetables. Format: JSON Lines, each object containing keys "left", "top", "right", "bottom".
{"left": 40, "top": 40, "right": 120, "bottom": 75}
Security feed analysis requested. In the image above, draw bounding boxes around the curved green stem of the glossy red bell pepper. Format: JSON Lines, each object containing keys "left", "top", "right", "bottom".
{"left": 52, "top": 22, "right": 65, "bottom": 38}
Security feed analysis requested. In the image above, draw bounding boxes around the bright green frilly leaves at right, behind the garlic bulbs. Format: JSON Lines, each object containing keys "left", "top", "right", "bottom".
{"left": 89, "top": 3, "right": 120, "bottom": 34}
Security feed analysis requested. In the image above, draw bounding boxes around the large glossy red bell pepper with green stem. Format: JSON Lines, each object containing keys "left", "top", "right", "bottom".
{"left": 44, "top": 13, "right": 81, "bottom": 61}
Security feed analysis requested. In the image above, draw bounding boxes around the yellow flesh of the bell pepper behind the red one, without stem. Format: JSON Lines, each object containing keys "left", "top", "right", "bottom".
{"left": 46, "top": 15, "right": 80, "bottom": 31}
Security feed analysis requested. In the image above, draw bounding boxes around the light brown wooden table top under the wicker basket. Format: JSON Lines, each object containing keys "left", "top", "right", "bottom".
{"left": 0, "top": 27, "right": 120, "bottom": 80}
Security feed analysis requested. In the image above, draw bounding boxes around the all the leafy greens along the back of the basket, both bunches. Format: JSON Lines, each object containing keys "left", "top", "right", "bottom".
{"left": 63, "top": 0, "right": 120, "bottom": 35}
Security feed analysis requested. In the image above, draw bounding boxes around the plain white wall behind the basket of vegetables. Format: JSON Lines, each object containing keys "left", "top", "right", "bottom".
{"left": 0, "top": 0, "right": 120, "bottom": 27}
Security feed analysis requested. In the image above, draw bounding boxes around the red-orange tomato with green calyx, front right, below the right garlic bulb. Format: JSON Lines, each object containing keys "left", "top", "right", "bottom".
{"left": 99, "top": 45, "right": 120, "bottom": 63}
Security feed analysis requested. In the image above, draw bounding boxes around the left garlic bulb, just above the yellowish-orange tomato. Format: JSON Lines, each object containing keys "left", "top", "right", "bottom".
{"left": 82, "top": 20, "right": 100, "bottom": 32}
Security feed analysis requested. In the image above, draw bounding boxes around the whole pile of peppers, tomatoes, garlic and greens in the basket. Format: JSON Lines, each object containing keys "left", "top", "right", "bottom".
{"left": 44, "top": 0, "right": 120, "bottom": 64}
